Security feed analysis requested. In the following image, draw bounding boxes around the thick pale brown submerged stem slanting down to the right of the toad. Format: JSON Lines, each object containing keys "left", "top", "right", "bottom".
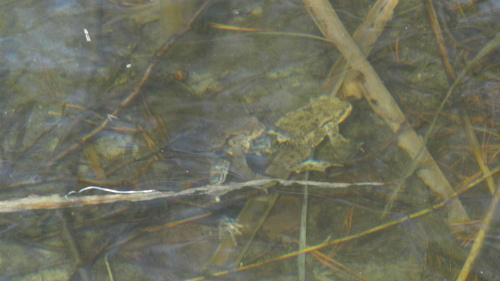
{"left": 304, "top": 0, "right": 469, "bottom": 221}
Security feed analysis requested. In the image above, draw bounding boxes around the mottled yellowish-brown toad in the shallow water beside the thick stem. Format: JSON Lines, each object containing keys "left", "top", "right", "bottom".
{"left": 207, "top": 96, "right": 352, "bottom": 179}
